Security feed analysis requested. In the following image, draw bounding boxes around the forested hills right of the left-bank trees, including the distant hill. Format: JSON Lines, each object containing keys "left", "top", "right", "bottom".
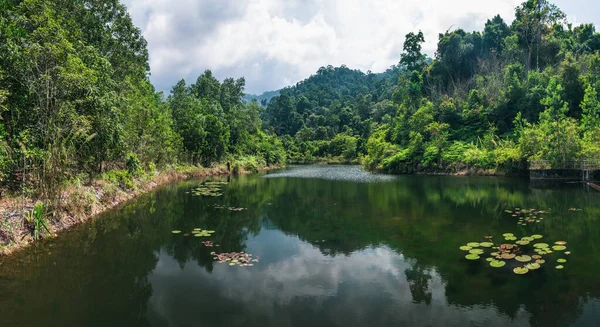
{"left": 262, "top": 0, "right": 600, "bottom": 173}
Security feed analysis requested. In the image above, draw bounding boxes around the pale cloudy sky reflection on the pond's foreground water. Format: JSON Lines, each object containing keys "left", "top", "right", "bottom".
{"left": 149, "top": 231, "right": 529, "bottom": 326}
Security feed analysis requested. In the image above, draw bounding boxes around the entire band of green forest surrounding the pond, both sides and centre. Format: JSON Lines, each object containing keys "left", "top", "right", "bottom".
{"left": 0, "top": 0, "right": 600, "bottom": 198}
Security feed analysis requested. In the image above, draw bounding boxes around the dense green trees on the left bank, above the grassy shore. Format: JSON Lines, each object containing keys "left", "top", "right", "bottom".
{"left": 0, "top": 0, "right": 285, "bottom": 198}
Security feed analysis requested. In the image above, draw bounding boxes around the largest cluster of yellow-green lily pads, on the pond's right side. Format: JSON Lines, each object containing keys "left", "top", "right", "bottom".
{"left": 459, "top": 233, "right": 570, "bottom": 275}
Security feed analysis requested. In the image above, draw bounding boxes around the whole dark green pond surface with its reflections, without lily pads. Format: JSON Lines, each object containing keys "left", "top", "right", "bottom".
{"left": 0, "top": 167, "right": 600, "bottom": 327}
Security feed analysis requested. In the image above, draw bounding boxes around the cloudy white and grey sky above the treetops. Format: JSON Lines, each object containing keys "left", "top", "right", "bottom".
{"left": 124, "top": 0, "right": 600, "bottom": 94}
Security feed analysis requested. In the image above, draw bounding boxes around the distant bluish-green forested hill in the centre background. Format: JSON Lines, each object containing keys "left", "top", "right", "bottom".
{"left": 262, "top": 66, "right": 400, "bottom": 161}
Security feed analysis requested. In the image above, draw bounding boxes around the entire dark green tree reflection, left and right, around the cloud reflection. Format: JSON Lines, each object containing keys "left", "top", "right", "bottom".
{"left": 0, "top": 170, "right": 600, "bottom": 326}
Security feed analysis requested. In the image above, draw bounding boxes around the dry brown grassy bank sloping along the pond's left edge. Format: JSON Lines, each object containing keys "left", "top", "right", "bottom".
{"left": 0, "top": 164, "right": 282, "bottom": 256}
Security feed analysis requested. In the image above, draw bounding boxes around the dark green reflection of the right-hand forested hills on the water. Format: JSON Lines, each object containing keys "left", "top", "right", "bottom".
{"left": 258, "top": 176, "right": 600, "bottom": 326}
